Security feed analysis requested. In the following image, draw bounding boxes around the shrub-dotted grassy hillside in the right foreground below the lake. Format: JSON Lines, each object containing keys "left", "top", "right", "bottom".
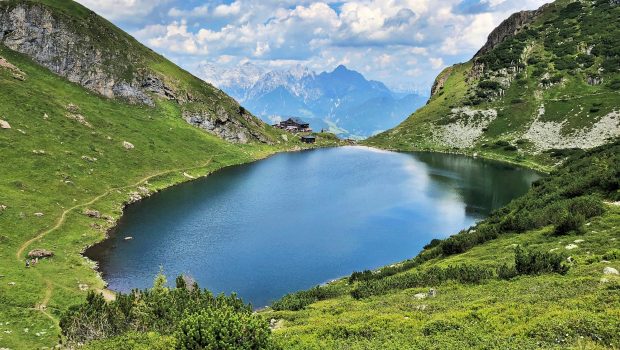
{"left": 263, "top": 143, "right": 620, "bottom": 349}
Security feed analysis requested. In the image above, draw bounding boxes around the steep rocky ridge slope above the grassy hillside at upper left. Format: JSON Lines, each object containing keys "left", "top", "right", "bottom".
{"left": 0, "top": 0, "right": 275, "bottom": 143}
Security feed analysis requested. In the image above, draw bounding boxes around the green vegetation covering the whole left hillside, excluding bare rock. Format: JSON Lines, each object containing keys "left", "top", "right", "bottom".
{"left": 0, "top": 0, "right": 337, "bottom": 349}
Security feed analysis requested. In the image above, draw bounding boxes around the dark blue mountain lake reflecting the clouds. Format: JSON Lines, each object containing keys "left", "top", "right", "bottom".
{"left": 87, "top": 147, "right": 539, "bottom": 306}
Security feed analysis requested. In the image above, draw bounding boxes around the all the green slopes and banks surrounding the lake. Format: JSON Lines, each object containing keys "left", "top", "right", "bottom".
{"left": 0, "top": 0, "right": 620, "bottom": 350}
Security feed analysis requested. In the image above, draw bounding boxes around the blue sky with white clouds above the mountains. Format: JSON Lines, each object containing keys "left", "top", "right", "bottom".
{"left": 78, "top": 0, "right": 548, "bottom": 91}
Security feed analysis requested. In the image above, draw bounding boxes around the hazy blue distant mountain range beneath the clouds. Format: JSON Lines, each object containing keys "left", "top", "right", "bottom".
{"left": 198, "top": 63, "right": 428, "bottom": 138}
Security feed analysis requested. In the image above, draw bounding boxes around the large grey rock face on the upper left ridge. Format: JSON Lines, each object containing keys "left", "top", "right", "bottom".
{"left": 0, "top": 3, "right": 162, "bottom": 105}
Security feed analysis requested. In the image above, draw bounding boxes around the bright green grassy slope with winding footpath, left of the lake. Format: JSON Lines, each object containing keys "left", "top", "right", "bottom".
{"left": 0, "top": 12, "right": 337, "bottom": 349}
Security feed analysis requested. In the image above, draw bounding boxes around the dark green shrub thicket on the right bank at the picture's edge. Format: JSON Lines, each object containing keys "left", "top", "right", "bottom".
{"left": 428, "top": 141, "right": 620, "bottom": 255}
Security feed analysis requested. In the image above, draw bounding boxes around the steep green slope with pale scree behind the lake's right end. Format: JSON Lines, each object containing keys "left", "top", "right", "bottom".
{"left": 368, "top": 0, "right": 620, "bottom": 167}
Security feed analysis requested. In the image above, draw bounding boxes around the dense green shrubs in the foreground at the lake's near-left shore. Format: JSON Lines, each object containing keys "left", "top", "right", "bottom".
{"left": 60, "top": 274, "right": 271, "bottom": 349}
